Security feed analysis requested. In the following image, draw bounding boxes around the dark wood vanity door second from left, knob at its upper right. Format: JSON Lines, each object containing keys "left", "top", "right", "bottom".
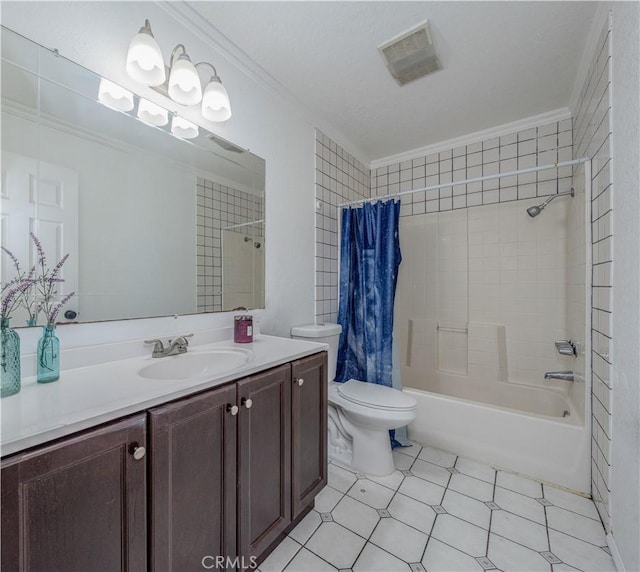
{"left": 149, "top": 384, "right": 237, "bottom": 572}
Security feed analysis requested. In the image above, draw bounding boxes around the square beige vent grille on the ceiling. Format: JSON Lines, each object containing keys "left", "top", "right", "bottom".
{"left": 378, "top": 21, "right": 442, "bottom": 85}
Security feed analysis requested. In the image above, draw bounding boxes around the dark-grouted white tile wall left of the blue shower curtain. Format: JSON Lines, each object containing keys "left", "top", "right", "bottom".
{"left": 315, "top": 129, "right": 370, "bottom": 323}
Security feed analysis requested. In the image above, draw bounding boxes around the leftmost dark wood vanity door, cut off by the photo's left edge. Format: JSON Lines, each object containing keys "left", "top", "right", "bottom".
{"left": 1, "top": 414, "right": 147, "bottom": 572}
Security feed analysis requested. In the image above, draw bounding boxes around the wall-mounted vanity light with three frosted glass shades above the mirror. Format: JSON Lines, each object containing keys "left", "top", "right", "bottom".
{"left": 126, "top": 20, "right": 231, "bottom": 121}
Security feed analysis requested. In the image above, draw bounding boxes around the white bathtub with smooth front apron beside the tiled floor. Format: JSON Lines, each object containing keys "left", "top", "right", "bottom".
{"left": 404, "top": 374, "right": 591, "bottom": 494}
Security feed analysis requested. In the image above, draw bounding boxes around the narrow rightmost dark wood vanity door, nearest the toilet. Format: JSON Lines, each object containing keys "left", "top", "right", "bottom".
{"left": 291, "top": 352, "right": 328, "bottom": 520}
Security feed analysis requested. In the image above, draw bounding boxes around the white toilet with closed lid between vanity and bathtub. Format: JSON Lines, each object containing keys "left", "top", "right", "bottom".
{"left": 291, "top": 324, "right": 417, "bottom": 476}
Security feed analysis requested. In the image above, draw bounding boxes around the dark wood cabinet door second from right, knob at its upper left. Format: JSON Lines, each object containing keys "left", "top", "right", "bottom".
{"left": 237, "top": 364, "right": 291, "bottom": 559}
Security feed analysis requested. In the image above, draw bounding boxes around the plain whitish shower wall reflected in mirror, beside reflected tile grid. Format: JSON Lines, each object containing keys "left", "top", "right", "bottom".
{"left": 222, "top": 229, "right": 264, "bottom": 310}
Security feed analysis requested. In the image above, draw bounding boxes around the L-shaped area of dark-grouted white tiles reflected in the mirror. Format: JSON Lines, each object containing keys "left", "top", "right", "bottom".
{"left": 196, "top": 177, "right": 264, "bottom": 312}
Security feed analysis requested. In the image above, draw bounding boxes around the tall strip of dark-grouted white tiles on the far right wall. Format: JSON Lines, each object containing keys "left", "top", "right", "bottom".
{"left": 573, "top": 15, "right": 613, "bottom": 530}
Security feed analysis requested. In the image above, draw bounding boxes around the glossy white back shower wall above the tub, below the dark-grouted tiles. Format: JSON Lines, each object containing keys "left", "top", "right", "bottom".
{"left": 394, "top": 198, "right": 572, "bottom": 394}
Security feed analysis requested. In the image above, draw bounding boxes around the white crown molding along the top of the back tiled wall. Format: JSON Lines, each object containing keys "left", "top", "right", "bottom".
{"left": 370, "top": 107, "right": 571, "bottom": 169}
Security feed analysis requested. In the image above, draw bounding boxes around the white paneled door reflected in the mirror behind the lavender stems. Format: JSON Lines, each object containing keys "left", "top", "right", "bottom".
{"left": 0, "top": 151, "right": 79, "bottom": 327}
